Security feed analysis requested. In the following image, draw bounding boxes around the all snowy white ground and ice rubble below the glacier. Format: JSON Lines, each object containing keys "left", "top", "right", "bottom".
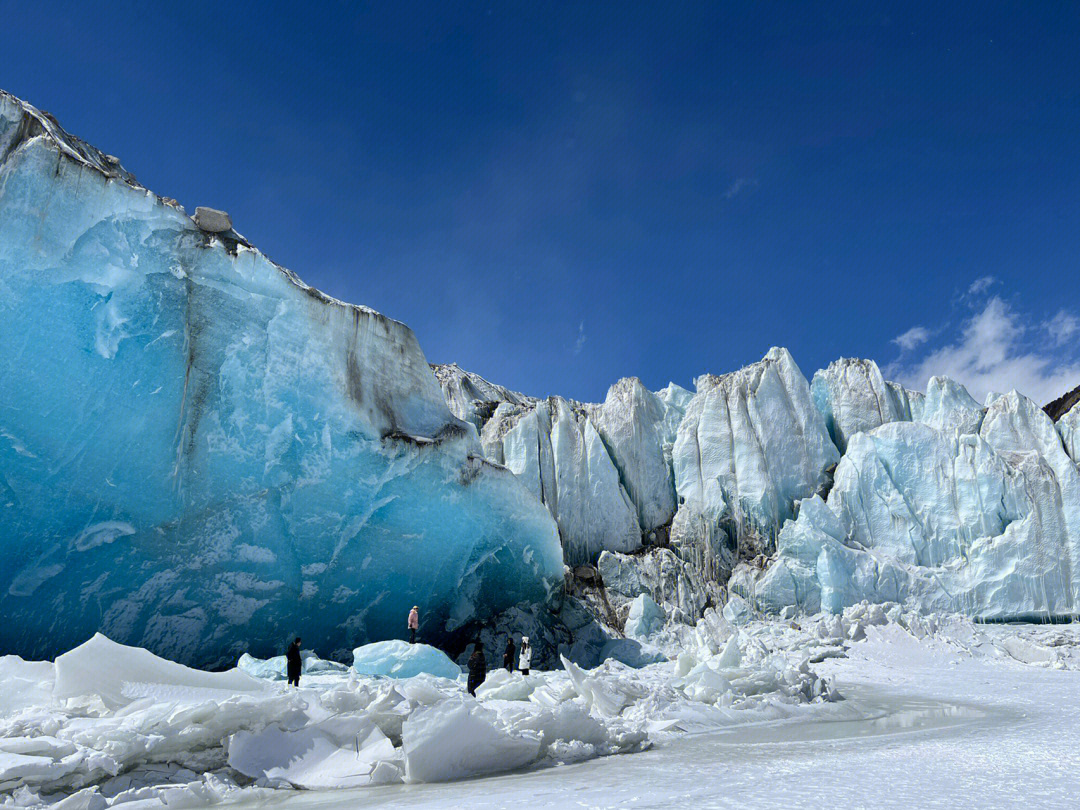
{"left": 0, "top": 607, "right": 1080, "bottom": 810}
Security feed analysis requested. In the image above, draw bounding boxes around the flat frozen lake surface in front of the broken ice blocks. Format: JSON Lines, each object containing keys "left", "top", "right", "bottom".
{"left": 230, "top": 630, "right": 1080, "bottom": 810}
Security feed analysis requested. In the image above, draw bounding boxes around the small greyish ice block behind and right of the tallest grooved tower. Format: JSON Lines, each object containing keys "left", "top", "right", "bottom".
{"left": 810, "top": 357, "right": 912, "bottom": 454}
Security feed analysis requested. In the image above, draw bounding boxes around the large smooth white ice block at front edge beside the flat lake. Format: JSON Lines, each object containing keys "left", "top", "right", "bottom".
{"left": 402, "top": 697, "right": 540, "bottom": 782}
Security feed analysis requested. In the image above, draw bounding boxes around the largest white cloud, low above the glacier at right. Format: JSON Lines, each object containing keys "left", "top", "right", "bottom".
{"left": 886, "top": 295, "right": 1080, "bottom": 405}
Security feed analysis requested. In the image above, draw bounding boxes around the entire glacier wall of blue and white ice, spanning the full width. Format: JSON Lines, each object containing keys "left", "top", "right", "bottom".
{"left": 0, "top": 84, "right": 1080, "bottom": 686}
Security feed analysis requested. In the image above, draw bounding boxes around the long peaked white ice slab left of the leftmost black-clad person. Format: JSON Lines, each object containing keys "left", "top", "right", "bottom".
{"left": 53, "top": 633, "right": 269, "bottom": 708}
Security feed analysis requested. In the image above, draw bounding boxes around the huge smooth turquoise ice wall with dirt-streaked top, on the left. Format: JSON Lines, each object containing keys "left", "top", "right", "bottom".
{"left": 0, "top": 94, "right": 563, "bottom": 664}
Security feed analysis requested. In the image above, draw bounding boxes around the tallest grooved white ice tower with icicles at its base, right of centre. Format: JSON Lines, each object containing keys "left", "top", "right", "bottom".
{"left": 672, "top": 348, "right": 840, "bottom": 581}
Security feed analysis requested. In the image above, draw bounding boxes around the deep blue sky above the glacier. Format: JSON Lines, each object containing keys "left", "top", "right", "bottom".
{"left": 6, "top": 2, "right": 1080, "bottom": 400}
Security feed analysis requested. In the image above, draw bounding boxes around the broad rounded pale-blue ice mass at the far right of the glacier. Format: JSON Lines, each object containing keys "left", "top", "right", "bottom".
{"left": 747, "top": 384, "right": 1080, "bottom": 619}
